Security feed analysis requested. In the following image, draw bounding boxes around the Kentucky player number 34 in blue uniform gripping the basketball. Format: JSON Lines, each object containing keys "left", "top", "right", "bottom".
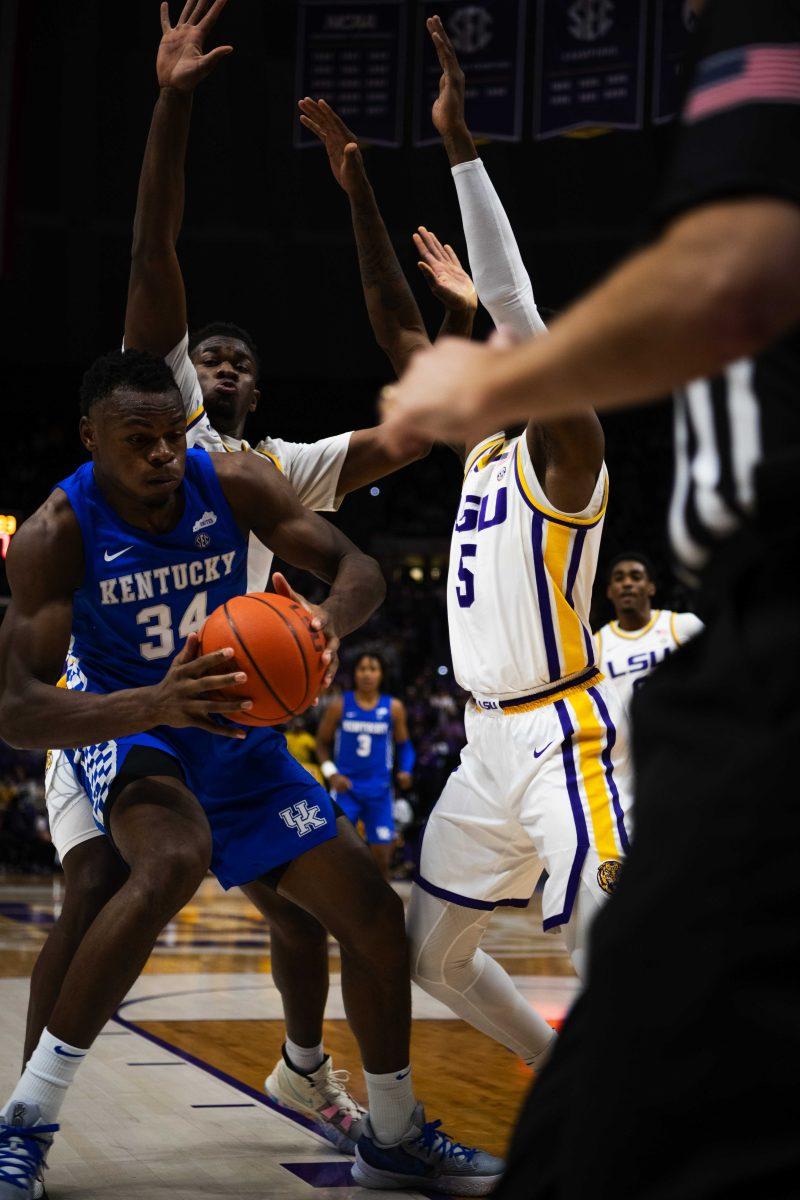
{"left": 0, "top": 350, "right": 503, "bottom": 1200}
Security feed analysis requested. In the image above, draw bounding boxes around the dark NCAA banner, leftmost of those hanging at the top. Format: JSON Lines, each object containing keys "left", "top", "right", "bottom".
{"left": 295, "top": 0, "right": 405, "bottom": 146}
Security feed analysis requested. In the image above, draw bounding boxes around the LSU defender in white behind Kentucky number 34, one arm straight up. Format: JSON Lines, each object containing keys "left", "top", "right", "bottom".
{"left": 25, "top": 4, "right": 474, "bottom": 1153}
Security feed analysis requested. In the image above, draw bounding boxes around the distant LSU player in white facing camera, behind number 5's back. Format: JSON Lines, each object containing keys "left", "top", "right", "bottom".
{"left": 595, "top": 551, "right": 703, "bottom": 710}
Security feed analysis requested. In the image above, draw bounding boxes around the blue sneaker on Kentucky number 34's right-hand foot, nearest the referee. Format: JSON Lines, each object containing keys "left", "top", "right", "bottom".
{"left": 353, "top": 1104, "right": 505, "bottom": 1196}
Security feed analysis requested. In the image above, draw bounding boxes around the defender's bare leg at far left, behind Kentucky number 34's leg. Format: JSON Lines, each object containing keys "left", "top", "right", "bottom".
{"left": 23, "top": 835, "right": 128, "bottom": 1067}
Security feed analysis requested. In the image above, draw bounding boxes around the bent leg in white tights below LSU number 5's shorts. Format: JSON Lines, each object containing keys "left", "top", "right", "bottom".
{"left": 407, "top": 883, "right": 555, "bottom": 1067}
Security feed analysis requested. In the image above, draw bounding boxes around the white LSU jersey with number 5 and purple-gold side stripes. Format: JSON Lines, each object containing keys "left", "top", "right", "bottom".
{"left": 447, "top": 434, "right": 608, "bottom": 708}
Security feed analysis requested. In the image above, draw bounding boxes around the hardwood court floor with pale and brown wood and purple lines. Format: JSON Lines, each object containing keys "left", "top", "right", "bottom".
{"left": 0, "top": 880, "right": 577, "bottom": 1200}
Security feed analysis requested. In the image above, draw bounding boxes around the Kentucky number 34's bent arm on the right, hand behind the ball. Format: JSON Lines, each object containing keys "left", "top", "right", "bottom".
{"left": 213, "top": 455, "right": 386, "bottom": 686}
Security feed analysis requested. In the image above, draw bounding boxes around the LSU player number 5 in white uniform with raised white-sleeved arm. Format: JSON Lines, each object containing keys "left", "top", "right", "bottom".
{"left": 408, "top": 18, "right": 630, "bottom": 1063}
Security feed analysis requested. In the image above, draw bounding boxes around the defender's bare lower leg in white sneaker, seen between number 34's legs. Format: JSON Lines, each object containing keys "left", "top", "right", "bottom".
{"left": 237, "top": 880, "right": 365, "bottom": 1154}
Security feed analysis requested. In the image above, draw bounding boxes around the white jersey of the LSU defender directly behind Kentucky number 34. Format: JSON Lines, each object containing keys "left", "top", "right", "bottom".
{"left": 164, "top": 332, "right": 350, "bottom": 592}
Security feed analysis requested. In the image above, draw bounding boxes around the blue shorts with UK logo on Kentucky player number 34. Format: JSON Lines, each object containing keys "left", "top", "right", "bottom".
{"left": 67, "top": 726, "right": 336, "bottom": 889}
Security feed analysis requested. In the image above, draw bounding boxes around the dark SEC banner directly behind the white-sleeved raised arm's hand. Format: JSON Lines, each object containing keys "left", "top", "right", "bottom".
{"left": 414, "top": 0, "right": 527, "bottom": 146}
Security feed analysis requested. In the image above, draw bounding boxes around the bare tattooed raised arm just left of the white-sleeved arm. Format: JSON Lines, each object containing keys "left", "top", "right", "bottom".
{"left": 300, "top": 97, "right": 431, "bottom": 376}
